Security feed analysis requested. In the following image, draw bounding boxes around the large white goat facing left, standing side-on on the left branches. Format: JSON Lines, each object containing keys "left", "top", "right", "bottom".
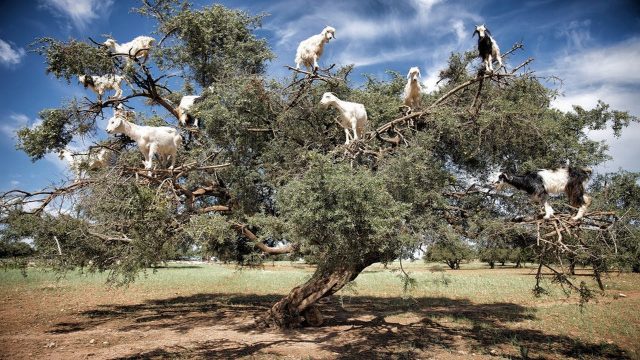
{"left": 107, "top": 110, "right": 182, "bottom": 174}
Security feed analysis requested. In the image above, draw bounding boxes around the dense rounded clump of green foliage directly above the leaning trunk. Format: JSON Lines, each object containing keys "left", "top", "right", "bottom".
{"left": 277, "top": 154, "right": 408, "bottom": 268}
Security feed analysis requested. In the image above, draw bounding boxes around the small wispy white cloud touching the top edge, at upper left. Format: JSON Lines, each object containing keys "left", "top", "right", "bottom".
{"left": 41, "top": 0, "right": 113, "bottom": 31}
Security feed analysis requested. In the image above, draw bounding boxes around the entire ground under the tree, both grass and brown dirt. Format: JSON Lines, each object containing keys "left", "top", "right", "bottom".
{"left": 0, "top": 262, "right": 640, "bottom": 359}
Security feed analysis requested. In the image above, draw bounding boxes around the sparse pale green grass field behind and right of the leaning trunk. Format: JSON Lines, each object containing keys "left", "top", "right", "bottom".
{"left": 0, "top": 262, "right": 640, "bottom": 358}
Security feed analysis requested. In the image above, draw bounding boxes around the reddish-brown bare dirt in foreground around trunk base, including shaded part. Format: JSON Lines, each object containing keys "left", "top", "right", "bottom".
{"left": 0, "top": 278, "right": 627, "bottom": 359}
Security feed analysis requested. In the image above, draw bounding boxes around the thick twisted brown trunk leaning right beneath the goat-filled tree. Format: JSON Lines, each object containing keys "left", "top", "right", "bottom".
{"left": 262, "top": 264, "right": 362, "bottom": 328}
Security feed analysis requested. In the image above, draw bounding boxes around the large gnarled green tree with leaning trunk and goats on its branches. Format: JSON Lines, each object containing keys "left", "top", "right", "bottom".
{"left": 0, "top": 0, "right": 638, "bottom": 327}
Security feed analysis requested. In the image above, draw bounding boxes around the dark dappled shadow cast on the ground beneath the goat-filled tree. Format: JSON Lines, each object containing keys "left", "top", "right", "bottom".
{"left": 50, "top": 294, "right": 629, "bottom": 359}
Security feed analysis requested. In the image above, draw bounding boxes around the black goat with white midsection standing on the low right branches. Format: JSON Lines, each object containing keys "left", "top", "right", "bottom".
{"left": 495, "top": 167, "right": 591, "bottom": 220}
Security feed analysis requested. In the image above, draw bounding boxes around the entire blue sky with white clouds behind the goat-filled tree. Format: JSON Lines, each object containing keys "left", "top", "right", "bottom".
{"left": 0, "top": 0, "right": 640, "bottom": 191}
